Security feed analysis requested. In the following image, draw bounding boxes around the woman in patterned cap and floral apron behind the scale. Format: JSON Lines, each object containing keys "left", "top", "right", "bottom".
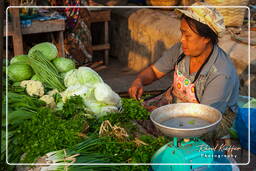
{"left": 129, "top": 2, "right": 239, "bottom": 139}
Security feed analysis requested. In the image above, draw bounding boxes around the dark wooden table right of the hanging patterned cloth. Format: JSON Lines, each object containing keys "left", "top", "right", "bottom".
{"left": 90, "top": 9, "right": 111, "bottom": 65}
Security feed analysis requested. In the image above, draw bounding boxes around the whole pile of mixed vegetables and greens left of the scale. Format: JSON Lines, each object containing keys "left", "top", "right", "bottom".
{"left": 1, "top": 42, "right": 169, "bottom": 171}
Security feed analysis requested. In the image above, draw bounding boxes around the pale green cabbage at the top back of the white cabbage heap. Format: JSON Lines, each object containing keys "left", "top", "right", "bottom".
{"left": 64, "top": 67, "right": 103, "bottom": 87}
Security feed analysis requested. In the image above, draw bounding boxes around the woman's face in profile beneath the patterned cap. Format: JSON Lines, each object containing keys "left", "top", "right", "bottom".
{"left": 180, "top": 18, "right": 210, "bottom": 57}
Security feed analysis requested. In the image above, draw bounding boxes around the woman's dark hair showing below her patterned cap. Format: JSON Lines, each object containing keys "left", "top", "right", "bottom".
{"left": 181, "top": 14, "right": 218, "bottom": 45}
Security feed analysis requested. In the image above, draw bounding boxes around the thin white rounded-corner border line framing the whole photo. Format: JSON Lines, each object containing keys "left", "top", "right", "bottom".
{"left": 5, "top": 6, "right": 251, "bottom": 166}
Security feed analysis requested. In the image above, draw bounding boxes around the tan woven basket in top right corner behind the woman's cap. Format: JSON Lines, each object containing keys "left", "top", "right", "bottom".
{"left": 204, "top": 0, "right": 248, "bottom": 27}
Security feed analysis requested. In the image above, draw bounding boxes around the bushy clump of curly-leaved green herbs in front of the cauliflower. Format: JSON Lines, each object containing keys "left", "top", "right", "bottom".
{"left": 15, "top": 108, "right": 84, "bottom": 163}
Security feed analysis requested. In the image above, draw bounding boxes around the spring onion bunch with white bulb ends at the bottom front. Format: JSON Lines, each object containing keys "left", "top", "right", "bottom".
{"left": 41, "top": 137, "right": 113, "bottom": 171}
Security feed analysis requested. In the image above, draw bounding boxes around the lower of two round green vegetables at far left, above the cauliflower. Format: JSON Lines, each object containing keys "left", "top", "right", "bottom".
{"left": 8, "top": 63, "right": 33, "bottom": 82}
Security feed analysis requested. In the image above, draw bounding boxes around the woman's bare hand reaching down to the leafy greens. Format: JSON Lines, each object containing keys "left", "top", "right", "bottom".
{"left": 128, "top": 79, "right": 144, "bottom": 100}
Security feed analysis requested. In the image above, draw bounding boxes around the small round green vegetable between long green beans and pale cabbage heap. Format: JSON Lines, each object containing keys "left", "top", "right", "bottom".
{"left": 53, "top": 58, "right": 75, "bottom": 72}
